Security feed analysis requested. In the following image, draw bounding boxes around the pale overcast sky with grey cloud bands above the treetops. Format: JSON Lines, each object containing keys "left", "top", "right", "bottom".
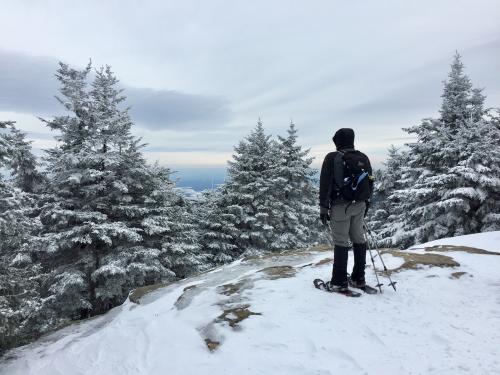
{"left": 0, "top": 0, "right": 500, "bottom": 168}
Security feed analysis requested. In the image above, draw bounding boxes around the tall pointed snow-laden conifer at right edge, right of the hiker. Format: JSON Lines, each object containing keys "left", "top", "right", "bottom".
{"left": 377, "top": 54, "right": 500, "bottom": 246}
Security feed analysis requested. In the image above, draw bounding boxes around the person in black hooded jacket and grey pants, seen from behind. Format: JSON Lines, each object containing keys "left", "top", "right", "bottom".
{"left": 319, "top": 128, "right": 373, "bottom": 292}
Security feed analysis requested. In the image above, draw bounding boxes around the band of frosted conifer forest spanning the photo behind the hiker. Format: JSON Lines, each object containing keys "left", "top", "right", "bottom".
{"left": 0, "top": 53, "right": 500, "bottom": 352}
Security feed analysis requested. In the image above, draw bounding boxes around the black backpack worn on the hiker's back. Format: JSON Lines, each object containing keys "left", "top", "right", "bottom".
{"left": 335, "top": 151, "right": 373, "bottom": 202}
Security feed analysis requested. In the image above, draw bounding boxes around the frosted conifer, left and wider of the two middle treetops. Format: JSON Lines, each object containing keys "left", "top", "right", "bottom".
{"left": 202, "top": 119, "right": 284, "bottom": 258}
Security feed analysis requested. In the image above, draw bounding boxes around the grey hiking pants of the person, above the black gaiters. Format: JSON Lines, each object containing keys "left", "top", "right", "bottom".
{"left": 330, "top": 202, "right": 366, "bottom": 247}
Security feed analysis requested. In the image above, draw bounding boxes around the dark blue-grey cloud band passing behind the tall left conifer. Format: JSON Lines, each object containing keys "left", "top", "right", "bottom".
{"left": 0, "top": 51, "right": 230, "bottom": 131}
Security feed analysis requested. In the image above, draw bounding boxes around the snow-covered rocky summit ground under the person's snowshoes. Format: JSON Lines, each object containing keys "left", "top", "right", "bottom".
{"left": 0, "top": 232, "right": 500, "bottom": 375}
